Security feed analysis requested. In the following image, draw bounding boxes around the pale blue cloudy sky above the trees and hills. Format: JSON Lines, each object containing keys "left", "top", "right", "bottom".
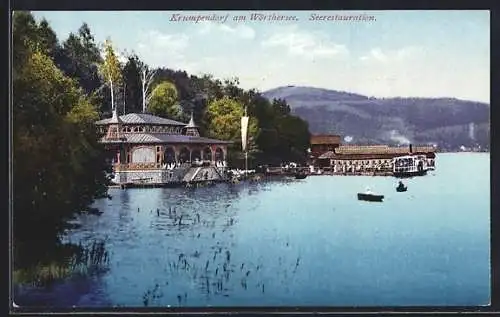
{"left": 34, "top": 10, "right": 490, "bottom": 102}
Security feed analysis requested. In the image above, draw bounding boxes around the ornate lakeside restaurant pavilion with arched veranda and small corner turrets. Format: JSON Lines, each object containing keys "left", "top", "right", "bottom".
{"left": 96, "top": 110, "right": 231, "bottom": 183}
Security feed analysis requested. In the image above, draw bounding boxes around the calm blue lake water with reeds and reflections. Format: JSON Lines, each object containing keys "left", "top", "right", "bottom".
{"left": 16, "top": 153, "right": 490, "bottom": 307}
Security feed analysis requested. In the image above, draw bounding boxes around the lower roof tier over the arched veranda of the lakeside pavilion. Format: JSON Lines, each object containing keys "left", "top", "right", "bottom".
{"left": 102, "top": 133, "right": 232, "bottom": 144}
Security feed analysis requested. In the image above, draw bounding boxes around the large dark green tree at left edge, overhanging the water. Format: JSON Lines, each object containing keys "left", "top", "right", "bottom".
{"left": 12, "top": 13, "right": 109, "bottom": 266}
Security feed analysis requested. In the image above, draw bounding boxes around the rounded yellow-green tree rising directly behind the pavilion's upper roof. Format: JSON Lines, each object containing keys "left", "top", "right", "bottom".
{"left": 148, "top": 81, "right": 182, "bottom": 120}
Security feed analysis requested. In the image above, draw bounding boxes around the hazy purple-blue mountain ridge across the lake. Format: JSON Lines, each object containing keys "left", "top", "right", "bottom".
{"left": 263, "top": 86, "right": 490, "bottom": 151}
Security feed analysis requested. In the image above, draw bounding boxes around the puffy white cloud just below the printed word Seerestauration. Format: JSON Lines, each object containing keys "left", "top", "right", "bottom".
{"left": 262, "top": 26, "right": 348, "bottom": 58}
